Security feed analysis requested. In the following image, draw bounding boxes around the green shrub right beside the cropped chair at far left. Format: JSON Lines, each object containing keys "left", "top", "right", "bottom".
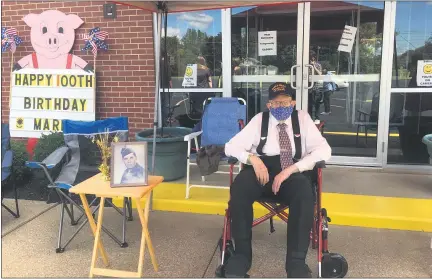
{"left": 11, "top": 140, "right": 31, "bottom": 184}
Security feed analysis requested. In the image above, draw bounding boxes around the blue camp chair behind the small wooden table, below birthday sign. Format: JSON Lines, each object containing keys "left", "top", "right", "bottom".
{"left": 26, "top": 117, "right": 132, "bottom": 253}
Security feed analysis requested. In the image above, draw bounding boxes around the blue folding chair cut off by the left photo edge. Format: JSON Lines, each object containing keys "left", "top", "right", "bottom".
{"left": 1, "top": 123, "right": 19, "bottom": 218}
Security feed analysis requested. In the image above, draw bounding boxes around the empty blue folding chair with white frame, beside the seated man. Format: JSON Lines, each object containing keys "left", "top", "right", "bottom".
{"left": 184, "top": 97, "right": 246, "bottom": 199}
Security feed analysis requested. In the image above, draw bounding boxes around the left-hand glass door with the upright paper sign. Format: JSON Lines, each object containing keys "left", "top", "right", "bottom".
{"left": 231, "top": 2, "right": 304, "bottom": 120}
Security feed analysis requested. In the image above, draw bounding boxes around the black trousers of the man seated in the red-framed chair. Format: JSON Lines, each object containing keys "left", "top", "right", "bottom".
{"left": 229, "top": 156, "right": 314, "bottom": 270}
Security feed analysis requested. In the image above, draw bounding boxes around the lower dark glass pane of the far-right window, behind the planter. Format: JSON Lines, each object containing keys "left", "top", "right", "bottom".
{"left": 387, "top": 93, "right": 432, "bottom": 165}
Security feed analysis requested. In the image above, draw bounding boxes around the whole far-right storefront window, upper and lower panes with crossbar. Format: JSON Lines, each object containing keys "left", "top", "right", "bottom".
{"left": 387, "top": 1, "right": 432, "bottom": 165}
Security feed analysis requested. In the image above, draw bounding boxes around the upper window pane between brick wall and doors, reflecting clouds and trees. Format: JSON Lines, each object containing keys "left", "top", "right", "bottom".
{"left": 162, "top": 10, "right": 222, "bottom": 88}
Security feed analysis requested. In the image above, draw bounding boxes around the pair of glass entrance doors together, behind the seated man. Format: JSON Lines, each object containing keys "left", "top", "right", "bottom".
{"left": 230, "top": 1, "right": 393, "bottom": 166}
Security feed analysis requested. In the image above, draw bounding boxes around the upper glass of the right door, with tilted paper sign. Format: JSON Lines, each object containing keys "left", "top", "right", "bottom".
{"left": 310, "top": 1, "right": 384, "bottom": 75}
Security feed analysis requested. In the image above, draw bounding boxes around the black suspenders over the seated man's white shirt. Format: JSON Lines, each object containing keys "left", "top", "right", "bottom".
{"left": 257, "top": 110, "right": 302, "bottom": 161}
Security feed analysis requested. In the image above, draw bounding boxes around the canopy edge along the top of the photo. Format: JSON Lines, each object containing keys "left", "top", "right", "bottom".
{"left": 111, "top": 0, "right": 298, "bottom": 13}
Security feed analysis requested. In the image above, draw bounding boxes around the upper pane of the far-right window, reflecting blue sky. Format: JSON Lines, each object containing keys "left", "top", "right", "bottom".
{"left": 392, "top": 1, "right": 432, "bottom": 88}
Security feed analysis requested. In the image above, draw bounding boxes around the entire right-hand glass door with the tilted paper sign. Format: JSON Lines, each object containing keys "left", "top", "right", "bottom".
{"left": 301, "top": 1, "right": 387, "bottom": 166}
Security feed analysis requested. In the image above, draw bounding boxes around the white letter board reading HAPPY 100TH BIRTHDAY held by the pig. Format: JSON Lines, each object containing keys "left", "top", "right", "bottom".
{"left": 9, "top": 69, "right": 96, "bottom": 138}
